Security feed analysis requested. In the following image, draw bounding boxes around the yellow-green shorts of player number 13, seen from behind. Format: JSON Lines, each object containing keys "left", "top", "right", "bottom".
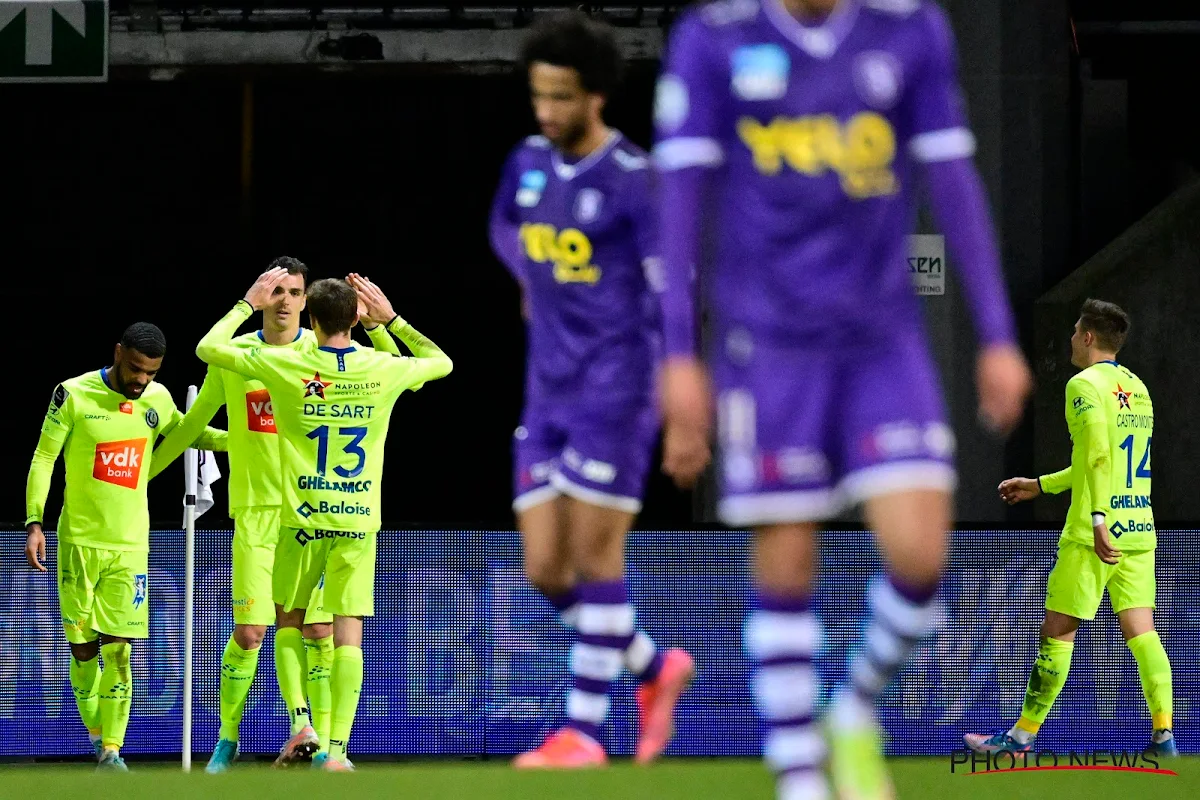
{"left": 272, "top": 528, "right": 376, "bottom": 616}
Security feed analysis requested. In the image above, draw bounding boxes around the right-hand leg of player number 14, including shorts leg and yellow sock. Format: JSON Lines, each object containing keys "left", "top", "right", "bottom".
{"left": 1108, "top": 551, "right": 1178, "bottom": 756}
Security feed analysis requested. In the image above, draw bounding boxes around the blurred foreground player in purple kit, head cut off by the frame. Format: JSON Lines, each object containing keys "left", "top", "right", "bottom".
{"left": 654, "top": 0, "right": 1031, "bottom": 800}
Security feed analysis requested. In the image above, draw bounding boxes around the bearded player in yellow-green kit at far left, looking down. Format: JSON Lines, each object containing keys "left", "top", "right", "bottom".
{"left": 25, "top": 323, "right": 224, "bottom": 771}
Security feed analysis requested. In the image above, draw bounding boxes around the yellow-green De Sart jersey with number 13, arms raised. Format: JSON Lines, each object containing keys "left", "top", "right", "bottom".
{"left": 196, "top": 301, "right": 452, "bottom": 531}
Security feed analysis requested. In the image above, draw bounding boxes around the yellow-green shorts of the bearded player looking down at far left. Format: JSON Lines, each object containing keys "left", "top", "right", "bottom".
{"left": 58, "top": 540, "right": 150, "bottom": 644}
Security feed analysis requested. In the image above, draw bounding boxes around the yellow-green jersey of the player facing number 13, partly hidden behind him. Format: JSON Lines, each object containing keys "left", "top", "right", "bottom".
{"left": 150, "top": 325, "right": 400, "bottom": 517}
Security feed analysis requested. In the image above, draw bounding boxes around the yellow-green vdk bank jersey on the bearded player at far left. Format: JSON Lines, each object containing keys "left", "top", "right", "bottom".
{"left": 25, "top": 369, "right": 224, "bottom": 551}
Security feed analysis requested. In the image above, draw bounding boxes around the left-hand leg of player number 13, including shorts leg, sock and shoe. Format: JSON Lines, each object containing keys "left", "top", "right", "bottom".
{"left": 271, "top": 528, "right": 331, "bottom": 766}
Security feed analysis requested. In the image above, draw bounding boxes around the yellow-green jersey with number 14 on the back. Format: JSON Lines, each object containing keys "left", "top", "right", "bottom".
{"left": 1038, "top": 361, "right": 1158, "bottom": 552}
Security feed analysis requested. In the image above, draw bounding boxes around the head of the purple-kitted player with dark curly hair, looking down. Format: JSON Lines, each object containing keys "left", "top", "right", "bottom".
{"left": 521, "top": 11, "right": 622, "bottom": 149}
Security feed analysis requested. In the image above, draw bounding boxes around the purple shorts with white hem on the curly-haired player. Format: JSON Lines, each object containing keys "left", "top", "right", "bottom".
{"left": 512, "top": 401, "right": 659, "bottom": 513}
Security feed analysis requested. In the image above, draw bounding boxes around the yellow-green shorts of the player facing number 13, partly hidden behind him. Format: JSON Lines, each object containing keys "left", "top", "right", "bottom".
{"left": 230, "top": 506, "right": 334, "bottom": 625}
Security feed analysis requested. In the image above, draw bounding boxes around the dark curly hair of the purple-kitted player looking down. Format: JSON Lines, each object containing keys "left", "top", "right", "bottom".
{"left": 521, "top": 11, "right": 622, "bottom": 95}
